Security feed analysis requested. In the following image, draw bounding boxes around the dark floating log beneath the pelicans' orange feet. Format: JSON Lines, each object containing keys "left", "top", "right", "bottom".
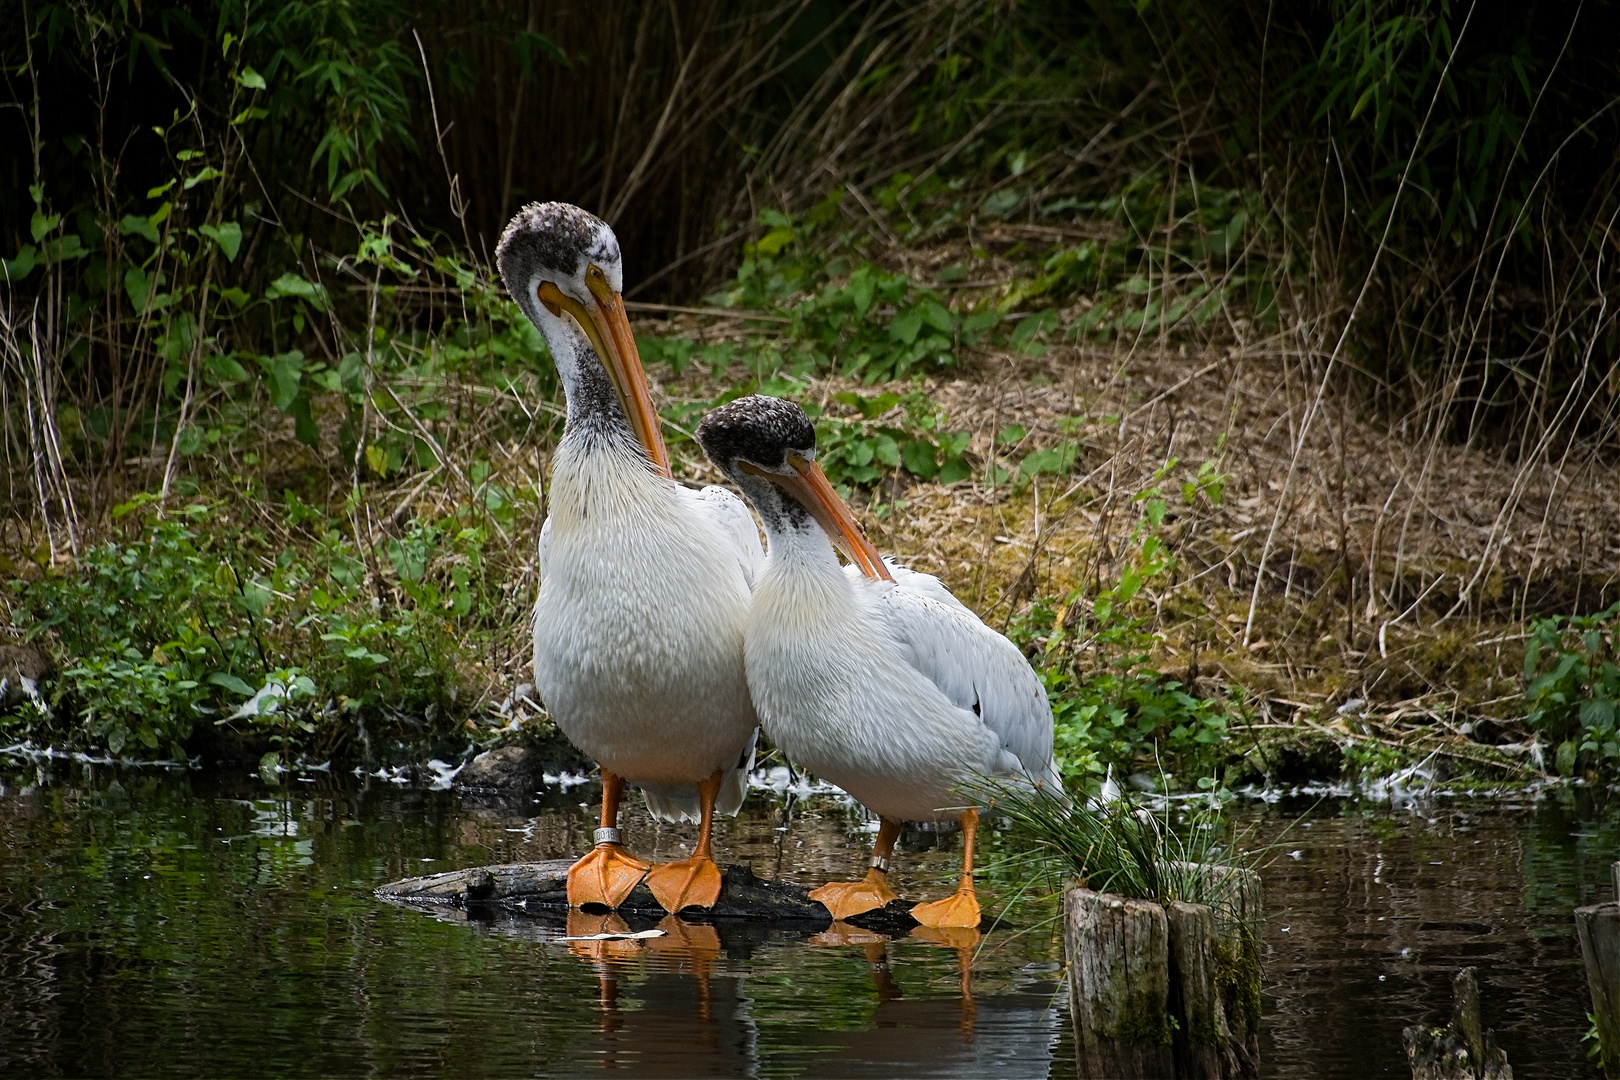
{"left": 374, "top": 858, "right": 917, "bottom": 934}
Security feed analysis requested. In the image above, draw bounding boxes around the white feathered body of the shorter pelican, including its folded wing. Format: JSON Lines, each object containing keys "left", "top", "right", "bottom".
{"left": 745, "top": 526, "right": 1061, "bottom": 821}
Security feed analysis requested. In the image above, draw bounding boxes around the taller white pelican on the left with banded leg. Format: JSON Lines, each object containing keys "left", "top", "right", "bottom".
{"left": 496, "top": 202, "right": 763, "bottom": 912}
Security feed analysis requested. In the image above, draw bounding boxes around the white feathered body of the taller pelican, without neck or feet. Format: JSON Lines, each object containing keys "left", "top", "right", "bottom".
{"left": 535, "top": 437, "right": 760, "bottom": 821}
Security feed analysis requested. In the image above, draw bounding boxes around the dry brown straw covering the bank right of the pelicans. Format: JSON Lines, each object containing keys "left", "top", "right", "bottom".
{"left": 803, "top": 335, "right": 1620, "bottom": 744}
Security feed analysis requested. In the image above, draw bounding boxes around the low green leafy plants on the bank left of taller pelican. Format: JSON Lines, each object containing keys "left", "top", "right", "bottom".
{"left": 0, "top": 494, "right": 507, "bottom": 758}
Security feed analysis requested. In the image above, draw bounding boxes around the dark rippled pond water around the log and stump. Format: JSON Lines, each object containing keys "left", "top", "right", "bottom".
{"left": 0, "top": 763, "right": 1620, "bottom": 1078}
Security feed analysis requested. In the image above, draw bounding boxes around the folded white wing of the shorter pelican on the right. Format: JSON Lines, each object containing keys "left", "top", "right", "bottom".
{"left": 846, "top": 563, "right": 1063, "bottom": 790}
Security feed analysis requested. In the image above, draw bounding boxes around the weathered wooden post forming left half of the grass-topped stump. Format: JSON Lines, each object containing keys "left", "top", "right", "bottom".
{"left": 1064, "top": 889, "right": 1176, "bottom": 1080}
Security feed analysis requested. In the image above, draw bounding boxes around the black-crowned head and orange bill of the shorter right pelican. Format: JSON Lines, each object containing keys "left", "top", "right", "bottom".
{"left": 697, "top": 393, "right": 893, "bottom": 580}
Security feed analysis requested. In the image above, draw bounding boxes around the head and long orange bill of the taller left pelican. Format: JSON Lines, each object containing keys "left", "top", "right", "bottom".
{"left": 496, "top": 202, "right": 669, "bottom": 476}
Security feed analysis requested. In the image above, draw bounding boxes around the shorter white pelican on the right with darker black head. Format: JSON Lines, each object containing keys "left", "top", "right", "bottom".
{"left": 698, "top": 395, "right": 1063, "bottom": 926}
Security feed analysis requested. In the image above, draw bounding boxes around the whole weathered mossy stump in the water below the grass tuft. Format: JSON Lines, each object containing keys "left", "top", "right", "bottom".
{"left": 1064, "top": 866, "right": 1260, "bottom": 1080}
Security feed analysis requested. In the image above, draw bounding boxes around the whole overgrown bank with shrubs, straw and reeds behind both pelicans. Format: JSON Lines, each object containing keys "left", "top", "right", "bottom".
{"left": 0, "top": 0, "right": 1620, "bottom": 793}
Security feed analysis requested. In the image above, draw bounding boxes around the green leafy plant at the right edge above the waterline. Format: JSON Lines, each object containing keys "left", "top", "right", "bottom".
{"left": 1524, "top": 604, "right": 1620, "bottom": 776}
